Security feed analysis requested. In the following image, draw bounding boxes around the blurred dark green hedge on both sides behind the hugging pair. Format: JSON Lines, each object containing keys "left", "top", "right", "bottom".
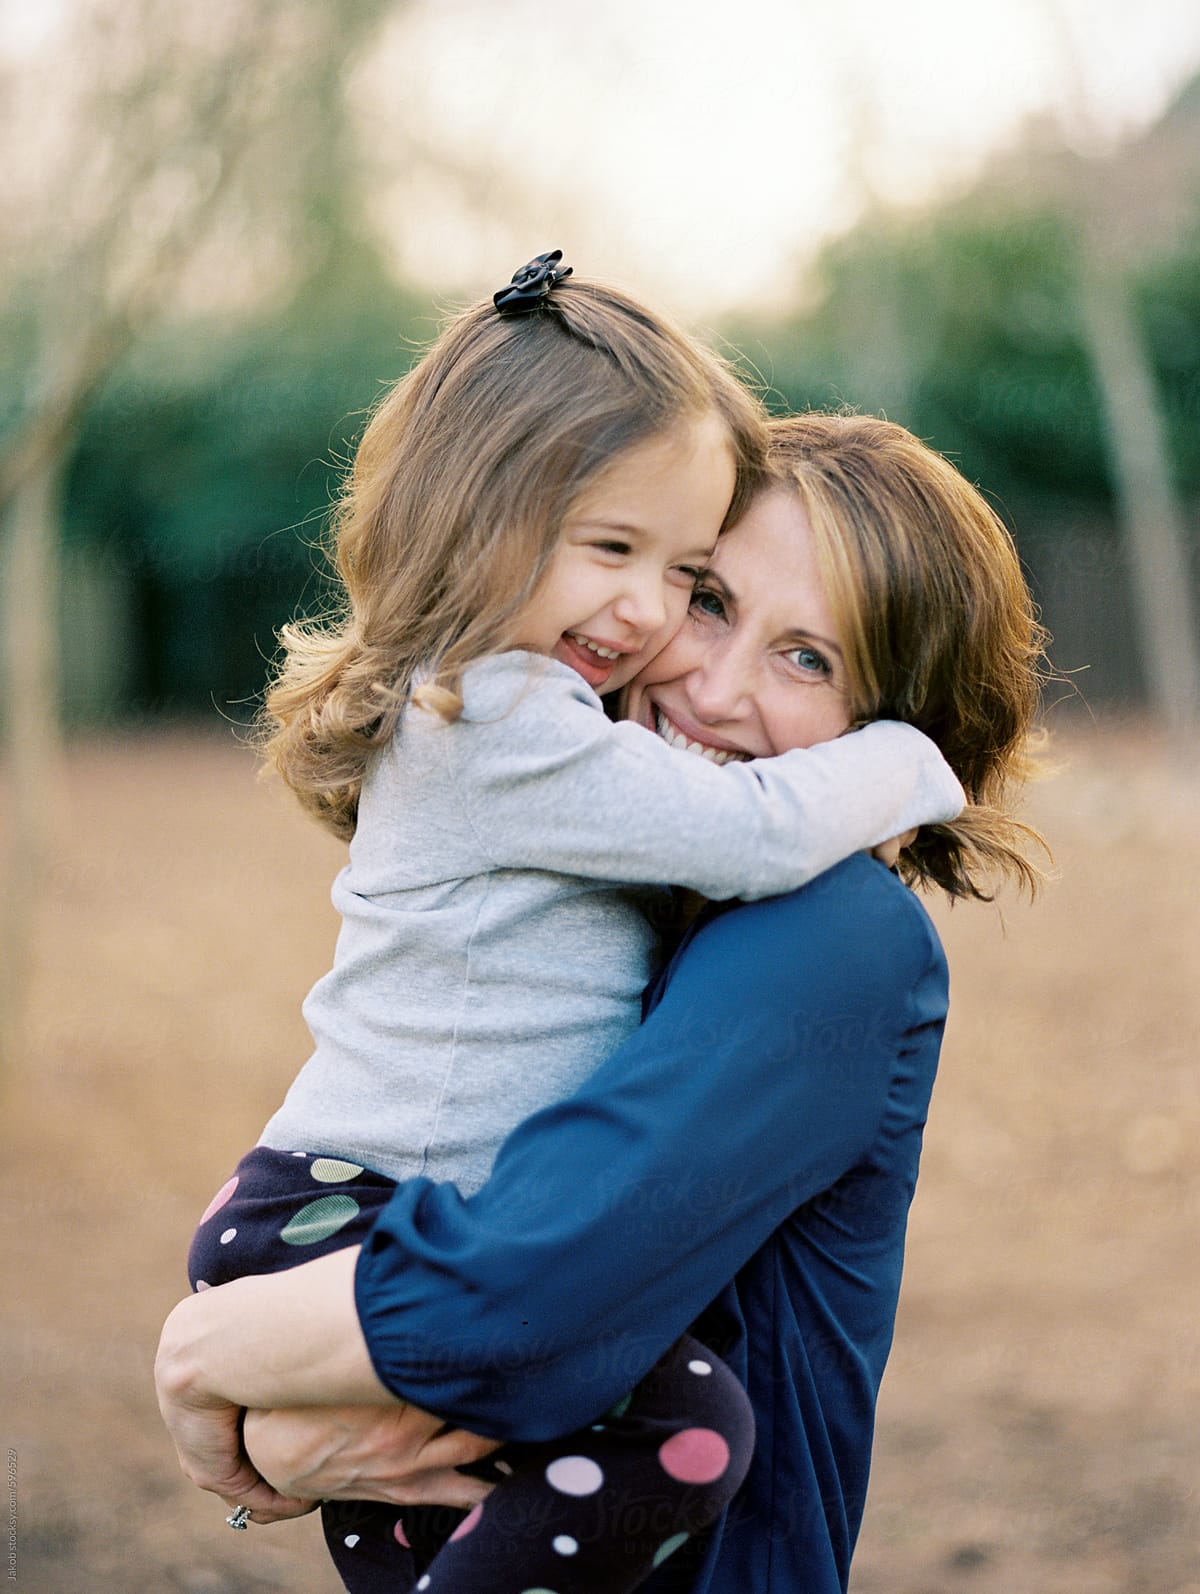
{"left": 16, "top": 73, "right": 1200, "bottom": 724}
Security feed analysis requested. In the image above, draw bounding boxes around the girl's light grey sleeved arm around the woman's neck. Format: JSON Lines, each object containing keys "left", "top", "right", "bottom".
{"left": 446, "top": 654, "right": 964, "bottom": 901}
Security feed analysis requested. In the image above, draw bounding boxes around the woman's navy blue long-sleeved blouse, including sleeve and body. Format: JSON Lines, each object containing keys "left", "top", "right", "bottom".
{"left": 355, "top": 854, "right": 947, "bottom": 1594}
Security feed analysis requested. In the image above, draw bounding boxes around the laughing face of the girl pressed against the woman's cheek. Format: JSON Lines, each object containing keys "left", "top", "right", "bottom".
{"left": 512, "top": 414, "right": 736, "bottom": 692}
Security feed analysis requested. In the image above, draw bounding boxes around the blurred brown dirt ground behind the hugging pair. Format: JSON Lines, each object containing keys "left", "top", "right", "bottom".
{"left": 0, "top": 725, "right": 1200, "bottom": 1594}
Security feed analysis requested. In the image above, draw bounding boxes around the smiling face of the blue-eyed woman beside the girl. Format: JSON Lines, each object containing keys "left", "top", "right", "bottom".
{"left": 623, "top": 488, "right": 851, "bottom": 764}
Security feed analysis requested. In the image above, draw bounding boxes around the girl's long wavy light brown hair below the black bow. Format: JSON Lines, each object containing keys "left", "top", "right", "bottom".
{"left": 260, "top": 277, "right": 765, "bottom": 837}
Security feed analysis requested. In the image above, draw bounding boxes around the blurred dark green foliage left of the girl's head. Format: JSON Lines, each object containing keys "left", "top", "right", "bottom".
{"left": 64, "top": 257, "right": 427, "bottom": 722}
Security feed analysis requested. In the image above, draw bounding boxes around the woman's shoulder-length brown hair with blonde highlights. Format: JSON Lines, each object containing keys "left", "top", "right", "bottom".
{"left": 768, "top": 413, "right": 1049, "bottom": 901}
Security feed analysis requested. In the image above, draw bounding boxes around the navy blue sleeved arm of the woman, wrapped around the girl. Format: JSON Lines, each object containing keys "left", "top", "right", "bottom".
{"left": 355, "top": 858, "right": 947, "bottom": 1439}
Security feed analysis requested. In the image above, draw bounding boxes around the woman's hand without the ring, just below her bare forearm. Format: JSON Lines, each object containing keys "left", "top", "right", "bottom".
{"left": 244, "top": 1404, "right": 500, "bottom": 1517}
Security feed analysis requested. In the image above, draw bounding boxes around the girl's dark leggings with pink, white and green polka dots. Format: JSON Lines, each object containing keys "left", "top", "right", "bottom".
{"left": 188, "top": 1146, "right": 754, "bottom": 1594}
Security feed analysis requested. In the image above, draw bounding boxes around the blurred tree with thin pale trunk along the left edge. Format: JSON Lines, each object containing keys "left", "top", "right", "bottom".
{"left": 0, "top": 0, "right": 403, "bottom": 1055}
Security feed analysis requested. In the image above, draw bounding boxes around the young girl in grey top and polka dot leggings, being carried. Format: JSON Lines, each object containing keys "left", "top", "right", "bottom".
{"left": 190, "top": 253, "right": 963, "bottom": 1594}
